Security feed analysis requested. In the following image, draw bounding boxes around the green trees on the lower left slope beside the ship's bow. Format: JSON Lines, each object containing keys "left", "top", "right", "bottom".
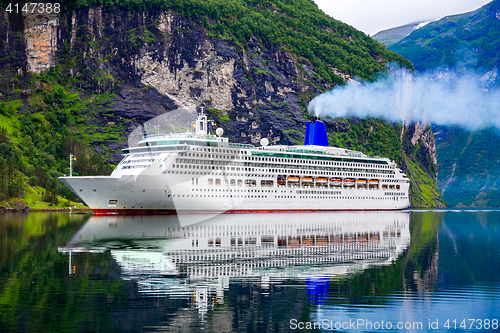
{"left": 0, "top": 67, "right": 116, "bottom": 209}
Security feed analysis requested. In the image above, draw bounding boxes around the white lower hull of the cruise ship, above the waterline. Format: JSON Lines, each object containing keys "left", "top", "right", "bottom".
{"left": 61, "top": 169, "right": 409, "bottom": 214}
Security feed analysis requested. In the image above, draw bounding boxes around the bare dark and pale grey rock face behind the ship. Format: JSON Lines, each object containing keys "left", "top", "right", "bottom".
{"left": 0, "top": 7, "right": 446, "bottom": 206}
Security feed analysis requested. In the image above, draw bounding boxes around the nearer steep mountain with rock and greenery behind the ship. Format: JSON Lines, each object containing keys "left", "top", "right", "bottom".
{"left": 0, "top": 0, "right": 443, "bottom": 206}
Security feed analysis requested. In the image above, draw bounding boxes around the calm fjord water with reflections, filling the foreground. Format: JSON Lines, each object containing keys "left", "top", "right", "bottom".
{"left": 0, "top": 211, "right": 500, "bottom": 332}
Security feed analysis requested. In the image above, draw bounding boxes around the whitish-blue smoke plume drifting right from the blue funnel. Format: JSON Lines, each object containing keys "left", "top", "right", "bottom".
{"left": 308, "top": 69, "right": 500, "bottom": 130}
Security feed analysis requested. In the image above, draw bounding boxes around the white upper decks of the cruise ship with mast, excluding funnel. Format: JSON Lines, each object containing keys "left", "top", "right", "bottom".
{"left": 114, "top": 112, "right": 402, "bottom": 178}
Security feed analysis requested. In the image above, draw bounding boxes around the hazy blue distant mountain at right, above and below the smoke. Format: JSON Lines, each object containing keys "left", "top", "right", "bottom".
{"left": 388, "top": 0, "right": 500, "bottom": 207}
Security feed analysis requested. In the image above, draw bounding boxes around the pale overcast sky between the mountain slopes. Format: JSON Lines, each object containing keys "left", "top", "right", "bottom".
{"left": 313, "top": 0, "right": 491, "bottom": 36}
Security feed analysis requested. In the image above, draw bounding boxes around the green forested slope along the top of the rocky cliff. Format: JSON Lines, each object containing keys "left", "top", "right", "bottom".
{"left": 74, "top": 0, "right": 413, "bottom": 84}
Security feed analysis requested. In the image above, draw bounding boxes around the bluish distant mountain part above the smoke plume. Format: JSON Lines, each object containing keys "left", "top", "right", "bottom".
{"left": 388, "top": 0, "right": 500, "bottom": 80}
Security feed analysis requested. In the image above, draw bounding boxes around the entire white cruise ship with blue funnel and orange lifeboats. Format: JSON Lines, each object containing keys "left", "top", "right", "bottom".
{"left": 59, "top": 109, "right": 410, "bottom": 214}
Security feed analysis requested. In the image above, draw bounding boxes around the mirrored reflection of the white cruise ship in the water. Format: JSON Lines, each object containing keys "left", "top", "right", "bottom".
{"left": 60, "top": 212, "right": 410, "bottom": 314}
